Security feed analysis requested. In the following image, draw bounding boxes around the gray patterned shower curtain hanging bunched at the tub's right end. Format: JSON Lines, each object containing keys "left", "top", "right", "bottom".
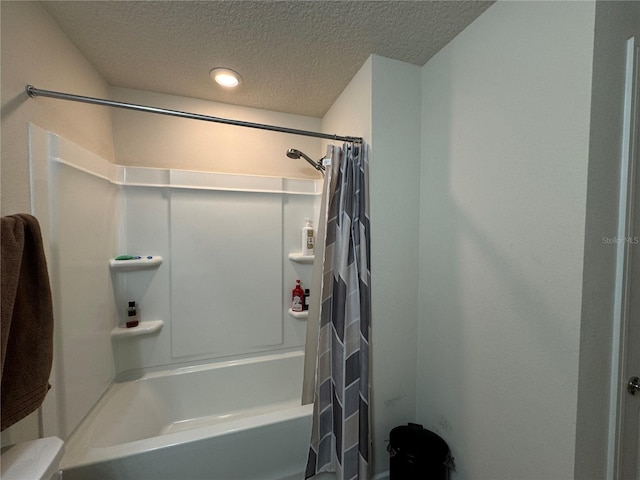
{"left": 305, "top": 143, "right": 371, "bottom": 480}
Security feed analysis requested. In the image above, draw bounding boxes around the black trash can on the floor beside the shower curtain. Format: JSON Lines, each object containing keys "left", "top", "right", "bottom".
{"left": 388, "top": 423, "right": 453, "bottom": 480}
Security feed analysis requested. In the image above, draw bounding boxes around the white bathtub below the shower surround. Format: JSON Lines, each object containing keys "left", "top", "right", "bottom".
{"left": 61, "top": 352, "right": 312, "bottom": 480}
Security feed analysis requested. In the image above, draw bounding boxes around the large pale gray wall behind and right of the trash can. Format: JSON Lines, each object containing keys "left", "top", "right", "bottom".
{"left": 417, "top": 2, "right": 595, "bottom": 480}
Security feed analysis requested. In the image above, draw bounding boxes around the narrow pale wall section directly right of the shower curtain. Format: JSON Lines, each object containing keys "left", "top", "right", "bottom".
{"left": 370, "top": 56, "right": 421, "bottom": 472}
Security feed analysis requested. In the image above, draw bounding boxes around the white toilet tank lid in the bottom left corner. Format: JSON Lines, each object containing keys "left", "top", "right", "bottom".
{"left": 0, "top": 437, "right": 64, "bottom": 480}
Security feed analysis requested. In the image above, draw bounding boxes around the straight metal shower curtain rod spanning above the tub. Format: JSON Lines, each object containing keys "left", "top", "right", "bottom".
{"left": 26, "top": 85, "right": 363, "bottom": 143}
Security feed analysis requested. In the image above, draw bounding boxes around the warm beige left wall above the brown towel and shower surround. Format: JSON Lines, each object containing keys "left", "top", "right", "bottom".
{"left": 1, "top": 1, "right": 114, "bottom": 215}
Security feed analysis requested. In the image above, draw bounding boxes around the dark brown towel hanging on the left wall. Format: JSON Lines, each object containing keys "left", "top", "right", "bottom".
{"left": 0, "top": 214, "right": 53, "bottom": 430}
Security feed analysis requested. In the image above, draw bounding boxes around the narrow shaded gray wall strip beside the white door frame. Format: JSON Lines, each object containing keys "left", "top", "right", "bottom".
{"left": 575, "top": 2, "right": 640, "bottom": 479}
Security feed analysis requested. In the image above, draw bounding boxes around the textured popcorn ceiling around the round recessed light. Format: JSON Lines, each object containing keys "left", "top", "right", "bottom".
{"left": 42, "top": 0, "right": 493, "bottom": 117}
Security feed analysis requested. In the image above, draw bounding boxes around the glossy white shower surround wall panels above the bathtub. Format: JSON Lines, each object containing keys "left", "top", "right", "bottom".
{"left": 30, "top": 125, "right": 322, "bottom": 438}
